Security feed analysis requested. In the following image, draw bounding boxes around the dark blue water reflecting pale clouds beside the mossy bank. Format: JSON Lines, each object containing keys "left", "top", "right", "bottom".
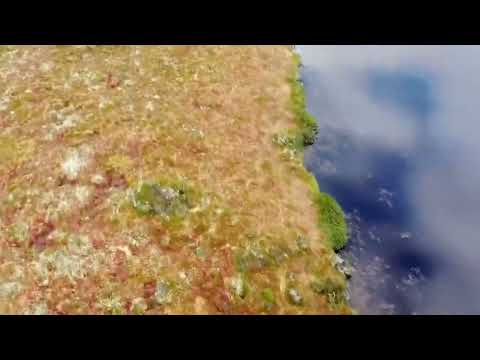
{"left": 298, "top": 46, "right": 480, "bottom": 314}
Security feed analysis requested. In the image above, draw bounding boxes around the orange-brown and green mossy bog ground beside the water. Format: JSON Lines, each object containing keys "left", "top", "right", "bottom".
{"left": 0, "top": 46, "right": 352, "bottom": 314}
